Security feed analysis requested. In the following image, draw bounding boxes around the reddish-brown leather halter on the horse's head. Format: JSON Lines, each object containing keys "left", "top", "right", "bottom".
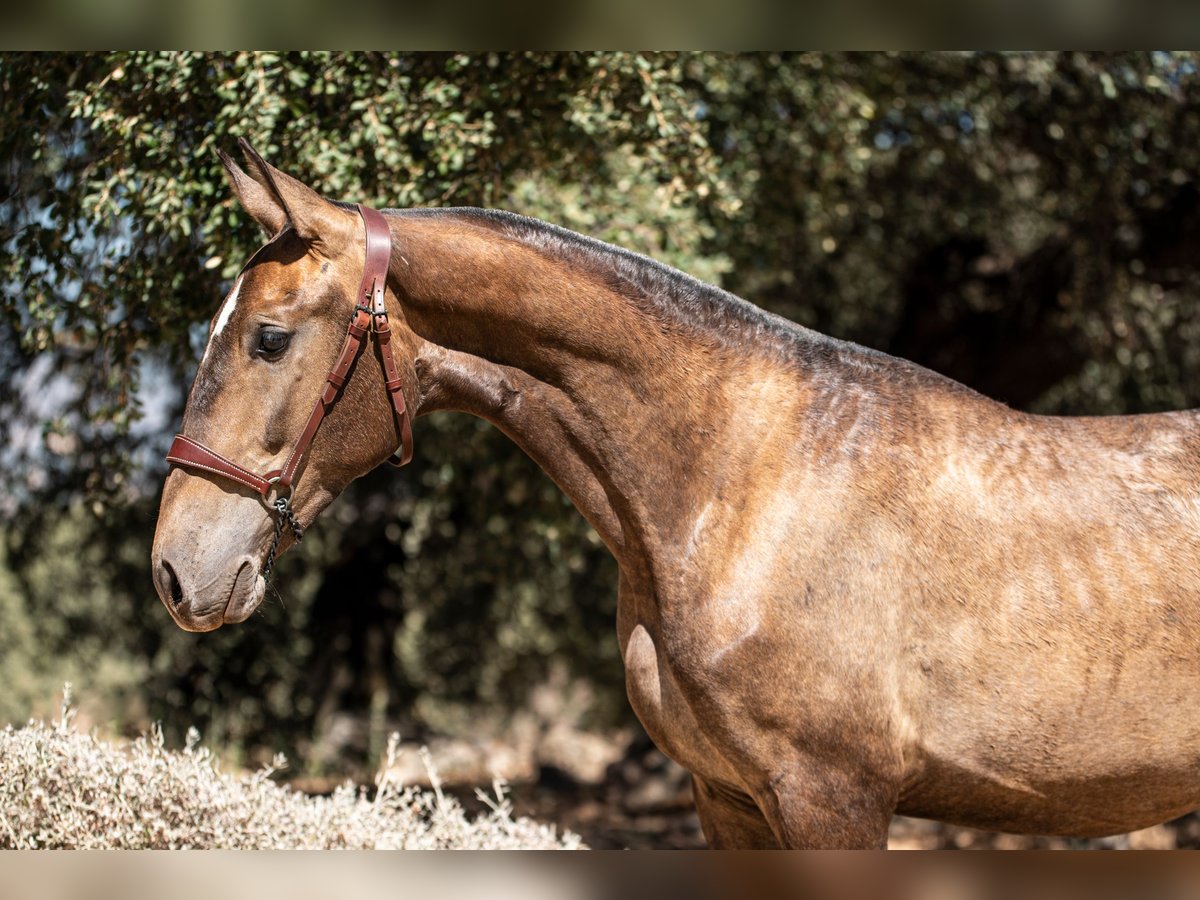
{"left": 167, "top": 203, "right": 413, "bottom": 577}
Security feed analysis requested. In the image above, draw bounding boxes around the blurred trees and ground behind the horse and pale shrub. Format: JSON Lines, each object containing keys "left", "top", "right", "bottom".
{"left": 0, "top": 52, "right": 1200, "bottom": 846}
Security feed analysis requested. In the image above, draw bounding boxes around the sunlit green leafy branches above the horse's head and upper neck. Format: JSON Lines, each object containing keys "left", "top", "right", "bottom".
{"left": 0, "top": 52, "right": 722, "bottom": 501}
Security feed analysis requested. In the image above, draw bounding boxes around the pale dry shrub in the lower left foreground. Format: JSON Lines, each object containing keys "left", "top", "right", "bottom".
{"left": 0, "top": 702, "right": 582, "bottom": 850}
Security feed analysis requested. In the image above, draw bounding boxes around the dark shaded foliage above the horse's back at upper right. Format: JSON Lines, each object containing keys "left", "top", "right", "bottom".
{"left": 698, "top": 53, "right": 1200, "bottom": 413}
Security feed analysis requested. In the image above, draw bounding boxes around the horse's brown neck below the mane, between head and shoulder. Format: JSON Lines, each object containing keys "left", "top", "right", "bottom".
{"left": 391, "top": 211, "right": 758, "bottom": 565}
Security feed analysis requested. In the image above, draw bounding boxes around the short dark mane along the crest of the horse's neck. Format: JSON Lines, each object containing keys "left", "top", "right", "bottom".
{"left": 379, "top": 206, "right": 974, "bottom": 403}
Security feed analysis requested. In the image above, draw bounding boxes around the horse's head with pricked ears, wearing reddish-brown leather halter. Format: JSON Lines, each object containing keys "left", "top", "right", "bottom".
{"left": 152, "top": 142, "right": 418, "bottom": 631}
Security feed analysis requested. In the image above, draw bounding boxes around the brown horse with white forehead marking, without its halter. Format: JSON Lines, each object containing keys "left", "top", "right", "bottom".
{"left": 154, "top": 144, "right": 1200, "bottom": 847}
